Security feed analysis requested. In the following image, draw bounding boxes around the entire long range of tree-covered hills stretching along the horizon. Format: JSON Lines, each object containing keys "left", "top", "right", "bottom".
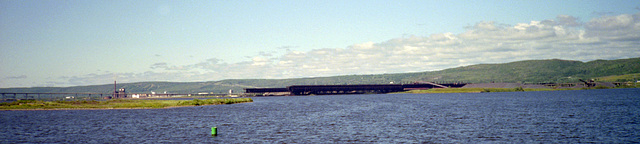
{"left": 0, "top": 58, "right": 640, "bottom": 93}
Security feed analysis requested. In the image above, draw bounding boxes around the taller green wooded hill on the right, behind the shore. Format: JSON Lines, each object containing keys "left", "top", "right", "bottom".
{"left": 403, "top": 58, "right": 640, "bottom": 83}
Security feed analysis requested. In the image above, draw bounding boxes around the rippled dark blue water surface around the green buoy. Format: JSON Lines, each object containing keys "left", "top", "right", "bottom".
{"left": 0, "top": 89, "right": 640, "bottom": 143}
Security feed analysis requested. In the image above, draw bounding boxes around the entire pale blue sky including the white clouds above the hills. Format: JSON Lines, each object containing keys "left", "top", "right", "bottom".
{"left": 0, "top": 0, "right": 640, "bottom": 88}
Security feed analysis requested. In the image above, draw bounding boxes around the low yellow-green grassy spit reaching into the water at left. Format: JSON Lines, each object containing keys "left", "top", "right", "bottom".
{"left": 0, "top": 98, "right": 253, "bottom": 110}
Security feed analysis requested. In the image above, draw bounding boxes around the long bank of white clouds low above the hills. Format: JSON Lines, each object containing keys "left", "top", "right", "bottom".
{"left": 57, "top": 13, "right": 640, "bottom": 85}
